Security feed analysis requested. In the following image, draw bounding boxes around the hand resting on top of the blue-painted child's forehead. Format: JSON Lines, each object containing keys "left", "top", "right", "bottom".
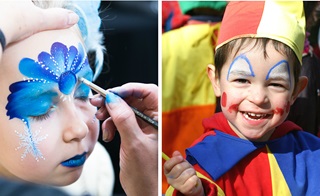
{"left": 0, "top": 0, "right": 79, "bottom": 56}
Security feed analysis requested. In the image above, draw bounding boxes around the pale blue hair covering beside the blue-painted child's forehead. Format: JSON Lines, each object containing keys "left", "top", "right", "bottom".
{"left": 67, "top": 0, "right": 105, "bottom": 80}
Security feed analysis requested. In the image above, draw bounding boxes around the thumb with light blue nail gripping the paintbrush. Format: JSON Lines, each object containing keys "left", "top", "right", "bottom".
{"left": 105, "top": 91, "right": 142, "bottom": 142}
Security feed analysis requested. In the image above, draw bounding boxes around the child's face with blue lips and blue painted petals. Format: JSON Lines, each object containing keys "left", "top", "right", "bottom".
{"left": 0, "top": 29, "right": 99, "bottom": 185}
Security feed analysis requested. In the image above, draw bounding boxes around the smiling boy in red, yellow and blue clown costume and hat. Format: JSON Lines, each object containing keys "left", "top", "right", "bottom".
{"left": 164, "top": 1, "right": 320, "bottom": 195}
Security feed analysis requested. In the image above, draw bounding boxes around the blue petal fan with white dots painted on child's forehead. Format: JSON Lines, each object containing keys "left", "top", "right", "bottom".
{"left": 19, "top": 42, "right": 89, "bottom": 95}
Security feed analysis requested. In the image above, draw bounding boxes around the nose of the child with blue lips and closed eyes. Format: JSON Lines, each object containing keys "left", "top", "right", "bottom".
{"left": 63, "top": 104, "right": 89, "bottom": 142}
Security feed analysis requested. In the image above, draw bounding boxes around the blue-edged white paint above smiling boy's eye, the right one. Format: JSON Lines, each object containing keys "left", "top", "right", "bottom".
{"left": 266, "top": 60, "right": 291, "bottom": 88}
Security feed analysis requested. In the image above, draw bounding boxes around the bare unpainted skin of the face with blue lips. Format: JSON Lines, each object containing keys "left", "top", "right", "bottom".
{"left": 0, "top": 29, "right": 99, "bottom": 186}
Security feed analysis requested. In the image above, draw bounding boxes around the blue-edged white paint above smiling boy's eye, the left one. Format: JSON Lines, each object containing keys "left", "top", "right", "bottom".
{"left": 227, "top": 54, "right": 255, "bottom": 80}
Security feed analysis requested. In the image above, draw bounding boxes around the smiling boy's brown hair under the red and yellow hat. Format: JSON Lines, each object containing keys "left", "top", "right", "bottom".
{"left": 214, "top": 37, "right": 301, "bottom": 89}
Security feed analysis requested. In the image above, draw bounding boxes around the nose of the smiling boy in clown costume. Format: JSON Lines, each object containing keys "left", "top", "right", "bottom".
{"left": 247, "top": 85, "right": 269, "bottom": 105}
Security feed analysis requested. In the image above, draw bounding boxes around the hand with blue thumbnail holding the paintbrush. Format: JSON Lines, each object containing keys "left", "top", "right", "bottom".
{"left": 90, "top": 83, "right": 158, "bottom": 196}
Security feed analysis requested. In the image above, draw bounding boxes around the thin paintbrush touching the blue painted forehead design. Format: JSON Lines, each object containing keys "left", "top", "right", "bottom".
{"left": 79, "top": 77, "right": 158, "bottom": 129}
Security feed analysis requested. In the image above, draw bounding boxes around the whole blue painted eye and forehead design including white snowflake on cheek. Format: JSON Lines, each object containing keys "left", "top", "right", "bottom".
{"left": 6, "top": 42, "right": 93, "bottom": 161}
